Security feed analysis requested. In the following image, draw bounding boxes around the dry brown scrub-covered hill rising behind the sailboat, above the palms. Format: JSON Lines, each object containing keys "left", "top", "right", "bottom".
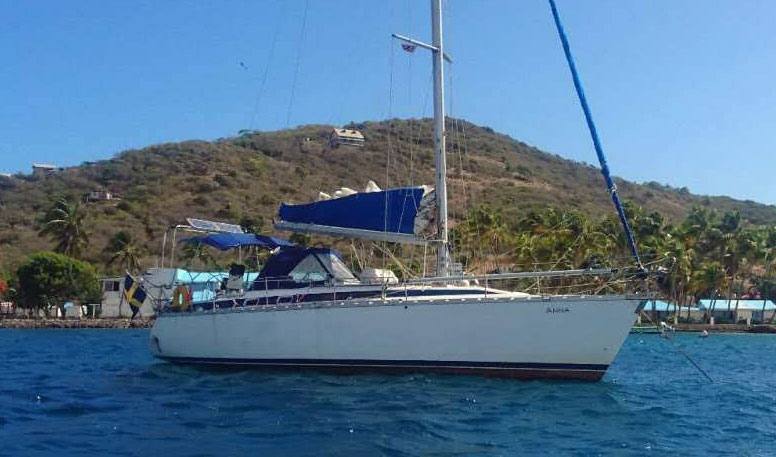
{"left": 0, "top": 119, "right": 776, "bottom": 269}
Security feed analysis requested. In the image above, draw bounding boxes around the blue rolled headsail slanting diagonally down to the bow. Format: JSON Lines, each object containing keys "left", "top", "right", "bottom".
{"left": 549, "top": 0, "right": 643, "bottom": 268}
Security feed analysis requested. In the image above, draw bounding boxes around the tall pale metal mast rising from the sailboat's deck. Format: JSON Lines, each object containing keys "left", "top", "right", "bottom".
{"left": 431, "top": 0, "right": 450, "bottom": 276}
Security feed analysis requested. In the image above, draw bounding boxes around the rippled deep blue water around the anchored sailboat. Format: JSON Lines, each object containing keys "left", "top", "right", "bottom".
{"left": 0, "top": 330, "right": 776, "bottom": 457}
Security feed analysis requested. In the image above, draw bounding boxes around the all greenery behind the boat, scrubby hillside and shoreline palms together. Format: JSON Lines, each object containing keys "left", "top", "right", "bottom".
{"left": 0, "top": 118, "right": 776, "bottom": 318}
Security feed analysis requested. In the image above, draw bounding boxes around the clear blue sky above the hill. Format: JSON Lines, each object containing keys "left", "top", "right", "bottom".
{"left": 0, "top": 0, "right": 776, "bottom": 204}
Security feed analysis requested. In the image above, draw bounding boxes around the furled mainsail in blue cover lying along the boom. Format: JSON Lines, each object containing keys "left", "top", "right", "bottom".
{"left": 275, "top": 183, "right": 435, "bottom": 244}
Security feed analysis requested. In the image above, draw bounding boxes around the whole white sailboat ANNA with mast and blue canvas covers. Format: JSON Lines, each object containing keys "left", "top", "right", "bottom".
{"left": 149, "top": 0, "right": 647, "bottom": 381}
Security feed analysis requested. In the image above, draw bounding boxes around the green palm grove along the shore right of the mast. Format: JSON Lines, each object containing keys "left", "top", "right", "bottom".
{"left": 453, "top": 205, "right": 776, "bottom": 314}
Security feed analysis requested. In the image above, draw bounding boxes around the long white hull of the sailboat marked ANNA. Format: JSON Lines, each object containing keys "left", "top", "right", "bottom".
{"left": 149, "top": 295, "right": 641, "bottom": 380}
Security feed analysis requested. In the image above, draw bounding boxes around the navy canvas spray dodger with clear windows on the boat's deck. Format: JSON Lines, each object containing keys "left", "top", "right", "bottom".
{"left": 251, "top": 247, "right": 359, "bottom": 290}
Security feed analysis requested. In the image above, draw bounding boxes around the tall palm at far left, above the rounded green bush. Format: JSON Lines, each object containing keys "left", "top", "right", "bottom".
{"left": 39, "top": 197, "right": 89, "bottom": 257}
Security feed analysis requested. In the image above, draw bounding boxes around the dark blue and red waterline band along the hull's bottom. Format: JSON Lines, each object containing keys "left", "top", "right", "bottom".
{"left": 157, "top": 356, "right": 608, "bottom": 381}
